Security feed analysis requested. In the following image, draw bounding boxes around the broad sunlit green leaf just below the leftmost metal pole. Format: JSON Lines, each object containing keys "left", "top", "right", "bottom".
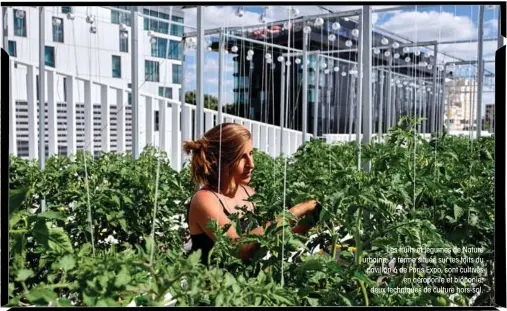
{"left": 33, "top": 221, "right": 74, "bottom": 254}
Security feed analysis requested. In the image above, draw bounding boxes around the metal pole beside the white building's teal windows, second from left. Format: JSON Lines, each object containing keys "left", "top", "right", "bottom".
{"left": 130, "top": 6, "right": 140, "bottom": 160}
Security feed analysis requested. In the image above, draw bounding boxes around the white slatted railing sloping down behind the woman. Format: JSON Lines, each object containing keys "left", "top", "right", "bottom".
{"left": 9, "top": 58, "right": 312, "bottom": 170}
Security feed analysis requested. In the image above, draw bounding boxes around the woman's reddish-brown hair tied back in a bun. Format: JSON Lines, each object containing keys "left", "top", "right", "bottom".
{"left": 183, "top": 123, "right": 252, "bottom": 189}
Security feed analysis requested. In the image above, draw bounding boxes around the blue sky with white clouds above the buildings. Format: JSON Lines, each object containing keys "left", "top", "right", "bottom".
{"left": 185, "top": 5, "right": 498, "bottom": 109}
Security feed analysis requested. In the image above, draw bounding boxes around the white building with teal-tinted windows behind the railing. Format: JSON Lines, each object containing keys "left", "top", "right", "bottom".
{"left": 2, "top": 6, "right": 184, "bottom": 157}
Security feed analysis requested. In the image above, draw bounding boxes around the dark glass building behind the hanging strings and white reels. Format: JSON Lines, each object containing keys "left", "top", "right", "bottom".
{"left": 220, "top": 17, "right": 441, "bottom": 136}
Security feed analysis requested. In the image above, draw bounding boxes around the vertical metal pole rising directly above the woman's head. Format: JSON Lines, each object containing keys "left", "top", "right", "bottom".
{"left": 194, "top": 6, "right": 206, "bottom": 139}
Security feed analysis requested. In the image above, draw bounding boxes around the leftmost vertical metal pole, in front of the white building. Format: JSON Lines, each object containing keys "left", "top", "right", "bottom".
{"left": 39, "top": 6, "right": 46, "bottom": 212}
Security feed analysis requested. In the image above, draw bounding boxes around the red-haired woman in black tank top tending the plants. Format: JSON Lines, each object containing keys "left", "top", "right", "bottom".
{"left": 183, "top": 123, "right": 317, "bottom": 264}
